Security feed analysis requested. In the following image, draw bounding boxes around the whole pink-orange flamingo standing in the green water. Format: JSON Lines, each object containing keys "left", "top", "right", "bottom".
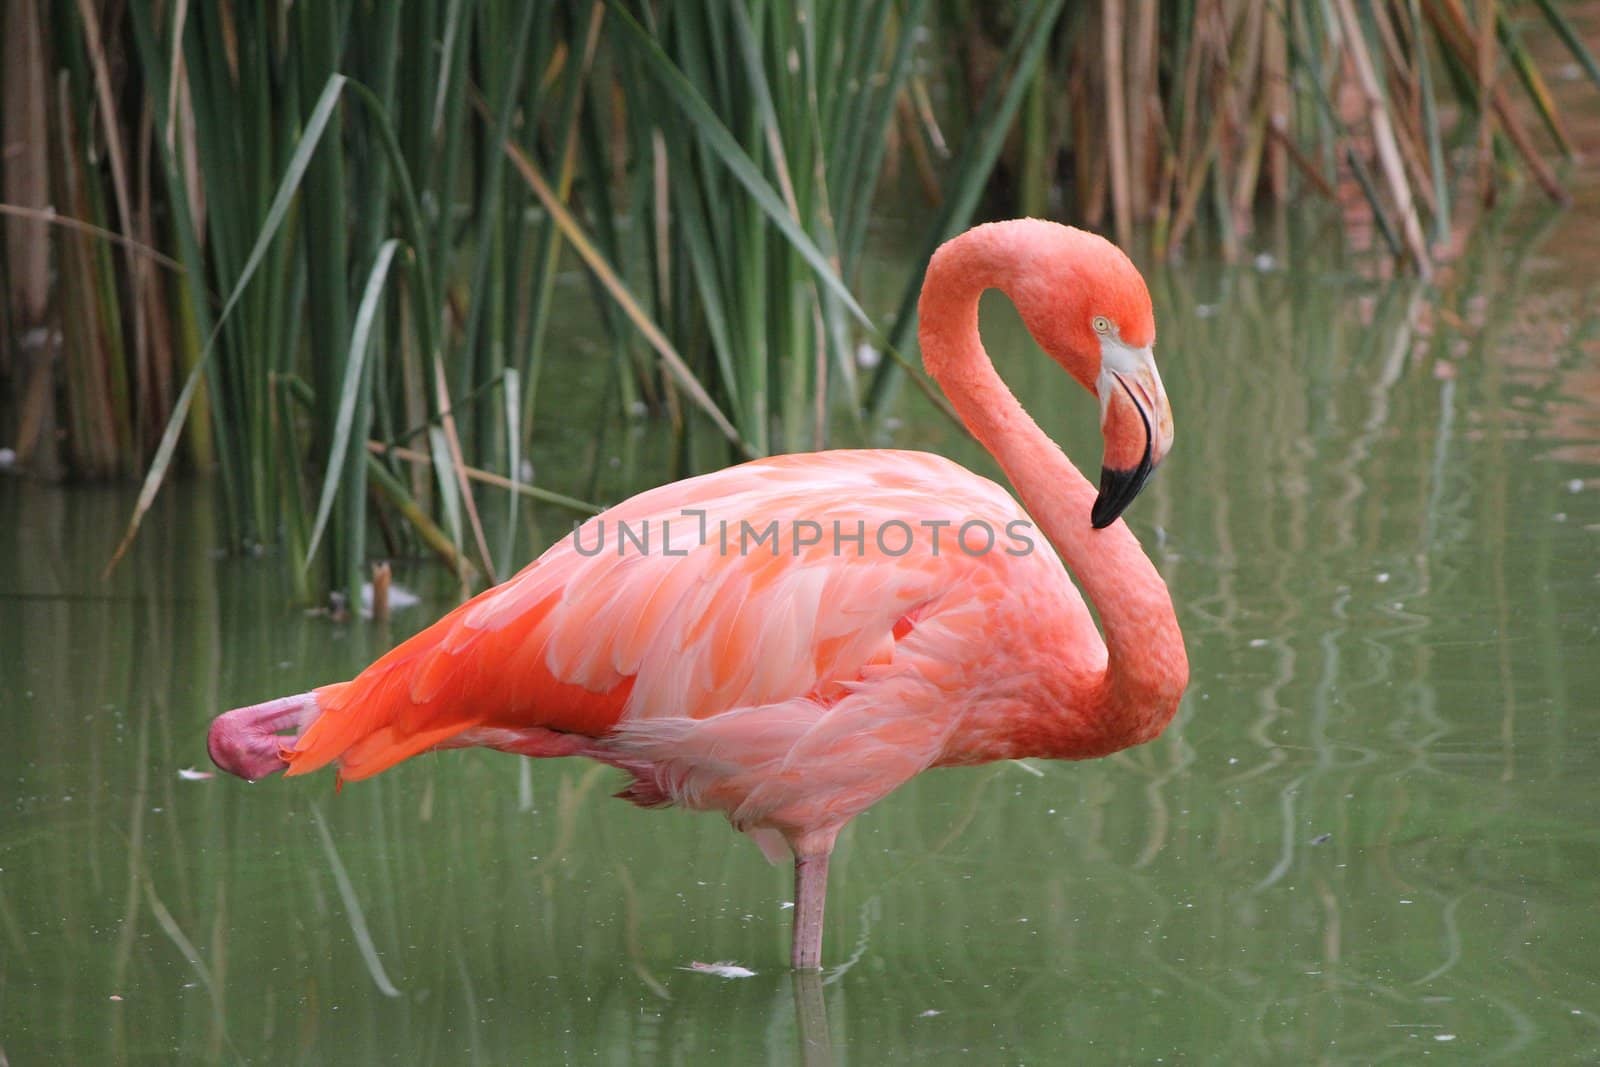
{"left": 208, "top": 219, "right": 1189, "bottom": 971}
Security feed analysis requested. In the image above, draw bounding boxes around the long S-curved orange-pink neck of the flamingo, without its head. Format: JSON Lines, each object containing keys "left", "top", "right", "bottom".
{"left": 918, "top": 219, "right": 1189, "bottom": 758}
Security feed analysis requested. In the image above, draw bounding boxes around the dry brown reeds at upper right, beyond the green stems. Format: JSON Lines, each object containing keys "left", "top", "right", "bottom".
{"left": 942, "top": 0, "right": 1600, "bottom": 277}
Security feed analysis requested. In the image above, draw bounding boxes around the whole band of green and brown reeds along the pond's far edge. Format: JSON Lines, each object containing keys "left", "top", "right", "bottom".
{"left": 0, "top": 0, "right": 1600, "bottom": 601}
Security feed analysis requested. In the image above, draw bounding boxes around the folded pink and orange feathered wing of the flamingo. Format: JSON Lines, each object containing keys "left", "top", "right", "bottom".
{"left": 285, "top": 451, "right": 1059, "bottom": 779}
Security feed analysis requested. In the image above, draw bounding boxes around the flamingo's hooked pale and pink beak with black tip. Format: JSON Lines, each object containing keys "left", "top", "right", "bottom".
{"left": 1090, "top": 348, "right": 1173, "bottom": 530}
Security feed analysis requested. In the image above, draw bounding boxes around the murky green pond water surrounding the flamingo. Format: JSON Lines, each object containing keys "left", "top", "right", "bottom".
{"left": 0, "top": 212, "right": 1600, "bottom": 1065}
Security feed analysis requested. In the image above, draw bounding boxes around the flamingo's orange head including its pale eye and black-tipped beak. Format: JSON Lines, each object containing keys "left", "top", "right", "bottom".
{"left": 1018, "top": 227, "right": 1173, "bottom": 530}
